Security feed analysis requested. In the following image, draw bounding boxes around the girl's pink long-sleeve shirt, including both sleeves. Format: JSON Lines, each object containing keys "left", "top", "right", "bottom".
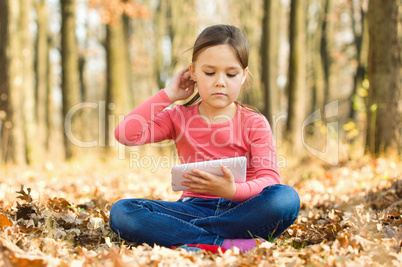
{"left": 115, "top": 90, "right": 280, "bottom": 202}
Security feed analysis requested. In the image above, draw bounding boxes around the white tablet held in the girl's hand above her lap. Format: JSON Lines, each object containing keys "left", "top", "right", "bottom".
{"left": 172, "top": 157, "right": 247, "bottom": 191}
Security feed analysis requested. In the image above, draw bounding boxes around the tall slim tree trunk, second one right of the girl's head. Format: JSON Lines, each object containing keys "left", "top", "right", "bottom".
{"left": 286, "top": 0, "right": 308, "bottom": 153}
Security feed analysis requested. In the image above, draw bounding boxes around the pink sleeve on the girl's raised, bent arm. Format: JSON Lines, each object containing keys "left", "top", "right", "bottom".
{"left": 114, "top": 90, "right": 173, "bottom": 146}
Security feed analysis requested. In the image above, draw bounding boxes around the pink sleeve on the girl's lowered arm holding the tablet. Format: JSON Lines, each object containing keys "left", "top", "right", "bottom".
{"left": 233, "top": 114, "right": 281, "bottom": 202}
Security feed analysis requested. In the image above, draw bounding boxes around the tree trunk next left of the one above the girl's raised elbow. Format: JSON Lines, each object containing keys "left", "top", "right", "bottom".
{"left": 61, "top": 0, "right": 81, "bottom": 159}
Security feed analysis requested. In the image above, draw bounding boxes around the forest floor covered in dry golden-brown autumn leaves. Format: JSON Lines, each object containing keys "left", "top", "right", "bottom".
{"left": 0, "top": 155, "right": 402, "bottom": 266}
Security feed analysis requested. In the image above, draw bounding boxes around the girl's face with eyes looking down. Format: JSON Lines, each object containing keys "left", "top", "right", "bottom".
{"left": 190, "top": 44, "right": 248, "bottom": 112}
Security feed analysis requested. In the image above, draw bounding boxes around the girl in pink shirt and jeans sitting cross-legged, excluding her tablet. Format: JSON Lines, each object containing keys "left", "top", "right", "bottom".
{"left": 110, "top": 25, "right": 300, "bottom": 252}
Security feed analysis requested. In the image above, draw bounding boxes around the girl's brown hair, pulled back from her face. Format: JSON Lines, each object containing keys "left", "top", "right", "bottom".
{"left": 183, "top": 24, "right": 249, "bottom": 107}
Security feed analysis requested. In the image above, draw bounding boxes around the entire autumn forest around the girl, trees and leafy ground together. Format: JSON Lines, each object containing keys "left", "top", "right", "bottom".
{"left": 0, "top": 0, "right": 402, "bottom": 266}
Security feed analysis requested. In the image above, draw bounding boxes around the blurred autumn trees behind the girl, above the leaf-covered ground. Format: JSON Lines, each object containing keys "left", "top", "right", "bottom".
{"left": 0, "top": 0, "right": 402, "bottom": 168}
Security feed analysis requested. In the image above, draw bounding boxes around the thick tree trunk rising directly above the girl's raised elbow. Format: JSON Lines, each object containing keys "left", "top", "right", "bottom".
{"left": 105, "top": 14, "right": 129, "bottom": 149}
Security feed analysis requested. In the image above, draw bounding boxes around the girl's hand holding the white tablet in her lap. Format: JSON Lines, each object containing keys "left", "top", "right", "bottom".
{"left": 182, "top": 166, "right": 236, "bottom": 199}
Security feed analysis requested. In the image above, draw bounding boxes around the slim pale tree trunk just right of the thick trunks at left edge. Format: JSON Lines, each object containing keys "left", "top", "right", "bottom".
{"left": 35, "top": 0, "right": 50, "bottom": 157}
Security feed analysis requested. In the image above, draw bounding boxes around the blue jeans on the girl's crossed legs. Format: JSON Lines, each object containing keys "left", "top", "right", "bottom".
{"left": 109, "top": 184, "right": 300, "bottom": 247}
